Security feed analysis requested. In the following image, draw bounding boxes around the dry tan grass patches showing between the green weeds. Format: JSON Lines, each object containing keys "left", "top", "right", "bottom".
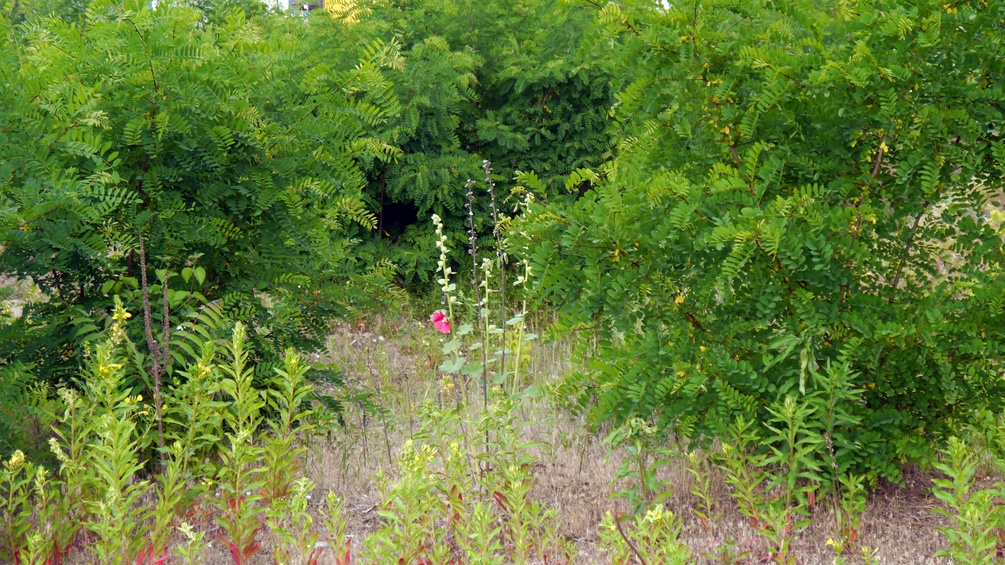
{"left": 299, "top": 318, "right": 964, "bottom": 565}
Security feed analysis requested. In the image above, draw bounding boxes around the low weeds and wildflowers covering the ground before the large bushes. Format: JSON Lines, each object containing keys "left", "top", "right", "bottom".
{"left": 0, "top": 182, "right": 1005, "bottom": 565}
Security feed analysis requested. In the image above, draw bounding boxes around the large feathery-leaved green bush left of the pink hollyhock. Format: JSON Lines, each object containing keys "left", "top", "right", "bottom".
{"left": 0, "top": 0, "right": 398, "bottom": 376}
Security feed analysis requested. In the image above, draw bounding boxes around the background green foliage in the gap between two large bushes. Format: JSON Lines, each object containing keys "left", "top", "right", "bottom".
{"left": 358, "top": 0, "right": 612, "bottom": 283}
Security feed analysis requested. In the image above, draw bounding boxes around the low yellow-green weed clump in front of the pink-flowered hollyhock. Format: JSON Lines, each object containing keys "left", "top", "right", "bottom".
{"left": 365, "top": 390, "right": 575, "bottom": 565}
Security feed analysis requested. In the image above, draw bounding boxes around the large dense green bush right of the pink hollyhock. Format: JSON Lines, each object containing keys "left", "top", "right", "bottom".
{"left": 515, "top": 0, "right": 1005, "bottom": 480}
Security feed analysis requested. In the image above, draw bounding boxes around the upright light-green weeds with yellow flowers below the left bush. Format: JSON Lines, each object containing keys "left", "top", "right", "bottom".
{"left": 0, "top": 305, "right": 319, "bottom": 565}
